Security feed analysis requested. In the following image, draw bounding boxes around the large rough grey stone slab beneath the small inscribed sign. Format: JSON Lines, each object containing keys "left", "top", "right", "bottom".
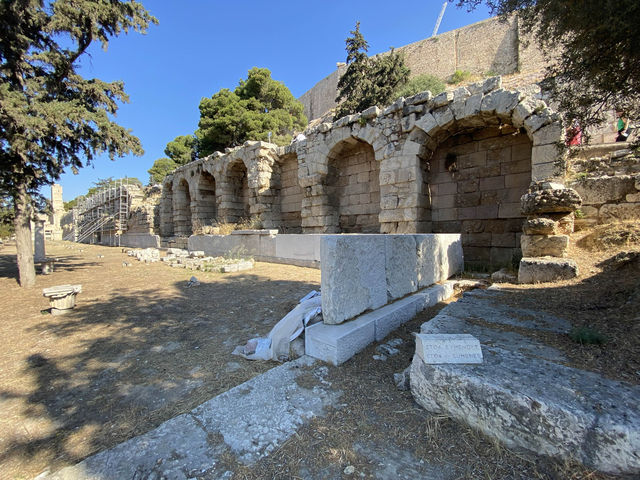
{"left": 411, "top": 289, "right": 640, "bottom": 473}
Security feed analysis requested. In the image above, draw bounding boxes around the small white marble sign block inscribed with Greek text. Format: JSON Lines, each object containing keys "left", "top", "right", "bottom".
{"left": 416, "top": 333, "right": 482, "bottom": 364}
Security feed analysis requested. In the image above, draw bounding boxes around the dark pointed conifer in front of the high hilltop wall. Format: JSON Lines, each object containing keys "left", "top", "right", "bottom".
{"left": 335, "top": 22, "right": 409, "bottom": 118}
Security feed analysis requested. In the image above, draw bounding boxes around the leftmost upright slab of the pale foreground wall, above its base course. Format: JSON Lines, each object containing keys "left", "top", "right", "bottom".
{"left": 320, "top": 235, "right": 387, "bottom": 324}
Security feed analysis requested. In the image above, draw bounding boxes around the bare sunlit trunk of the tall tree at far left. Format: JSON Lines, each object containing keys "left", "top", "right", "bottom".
{"left": 14, "top": 185, "right": 36, "bottom": 287}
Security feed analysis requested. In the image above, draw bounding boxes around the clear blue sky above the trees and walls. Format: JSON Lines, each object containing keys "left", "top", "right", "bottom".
{"left": 57, "top": 0, "right": 489, "bottom": 201}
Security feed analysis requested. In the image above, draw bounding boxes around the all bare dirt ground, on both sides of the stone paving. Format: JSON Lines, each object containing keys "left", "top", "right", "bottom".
{"left": 0, "top": 226, "right": 640, "bottom": 480}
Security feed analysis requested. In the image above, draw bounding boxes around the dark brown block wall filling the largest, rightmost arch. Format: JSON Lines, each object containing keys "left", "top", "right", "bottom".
{"left": 429, "top": 128, "right": 531, "bottom": 267}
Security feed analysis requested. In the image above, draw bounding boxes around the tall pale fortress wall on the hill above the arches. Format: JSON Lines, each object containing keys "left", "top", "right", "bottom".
{"left": 299, "top": 18, "right": 546, "bottom": 119}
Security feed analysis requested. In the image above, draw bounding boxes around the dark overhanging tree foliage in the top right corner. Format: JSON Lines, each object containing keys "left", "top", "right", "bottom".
{"left": 457, "top": 0, "right": 640, "bottom": 135}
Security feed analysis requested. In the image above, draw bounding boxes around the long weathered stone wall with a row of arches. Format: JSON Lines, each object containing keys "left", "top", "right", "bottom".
{"left": 160, "top": 77, "right": 565, "bottom": 265}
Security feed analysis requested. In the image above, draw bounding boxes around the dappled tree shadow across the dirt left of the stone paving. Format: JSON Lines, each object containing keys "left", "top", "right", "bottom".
{"left": 0, "top": 272, "right": 318, "bottom": 478}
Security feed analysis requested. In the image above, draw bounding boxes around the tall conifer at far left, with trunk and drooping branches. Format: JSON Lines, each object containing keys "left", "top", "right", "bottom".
{"left": 0, "top": 0, "right": 157, "bottom": 286}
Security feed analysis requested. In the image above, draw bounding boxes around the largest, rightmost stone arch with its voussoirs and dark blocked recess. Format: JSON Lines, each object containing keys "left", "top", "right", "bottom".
{"left": 405, "top": 84, "right": 563, "bottom": 268}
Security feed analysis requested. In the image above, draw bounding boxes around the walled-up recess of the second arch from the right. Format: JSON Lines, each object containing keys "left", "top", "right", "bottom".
{"left": 323, "top": 137, "right": 380, "bottom": 233}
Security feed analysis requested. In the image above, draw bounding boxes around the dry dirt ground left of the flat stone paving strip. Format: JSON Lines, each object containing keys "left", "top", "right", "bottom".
{"left": 0, "top": 242, "right": 320, "bottom": 480}
